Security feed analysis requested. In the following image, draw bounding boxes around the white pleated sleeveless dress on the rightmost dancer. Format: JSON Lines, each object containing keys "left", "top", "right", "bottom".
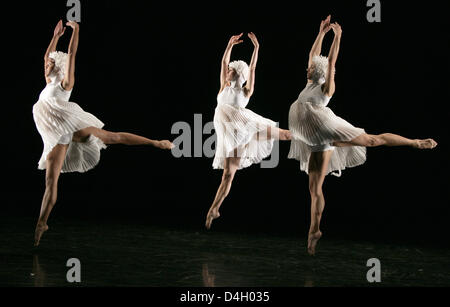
{"left": 288, "top": 82, "right": 366, "bottom": 177}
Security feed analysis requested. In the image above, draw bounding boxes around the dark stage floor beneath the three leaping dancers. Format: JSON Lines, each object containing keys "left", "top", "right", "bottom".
{"left": 0, "top": 218, "right": 450, "bottom": 287}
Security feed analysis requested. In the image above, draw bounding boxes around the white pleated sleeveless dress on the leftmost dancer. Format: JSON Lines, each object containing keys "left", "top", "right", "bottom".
{"left": 33, "top": 74, "right": 106, "bottom": 173}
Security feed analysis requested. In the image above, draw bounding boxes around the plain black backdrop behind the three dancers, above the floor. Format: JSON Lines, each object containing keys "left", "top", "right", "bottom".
{"left": 2, "top": 1, "right": 450, "bottom": 245}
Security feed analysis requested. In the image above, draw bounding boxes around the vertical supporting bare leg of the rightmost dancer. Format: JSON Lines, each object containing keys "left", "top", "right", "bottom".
{"left": 308, "top": 150, "right": 333, "bottom": 255}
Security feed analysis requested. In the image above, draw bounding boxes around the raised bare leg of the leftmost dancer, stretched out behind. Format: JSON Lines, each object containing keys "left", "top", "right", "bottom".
{"left": 73, "top": 127, "right": 174, "bottom": 149}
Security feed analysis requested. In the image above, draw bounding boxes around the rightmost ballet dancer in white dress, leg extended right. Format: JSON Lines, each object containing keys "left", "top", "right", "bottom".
{"left": 288, "top": 16, "right": 437, "bottom": 255}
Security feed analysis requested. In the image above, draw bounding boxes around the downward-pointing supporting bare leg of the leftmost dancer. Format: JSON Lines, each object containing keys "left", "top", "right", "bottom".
{"left": 34, "top": 144, "right": 69, "bottom": 246}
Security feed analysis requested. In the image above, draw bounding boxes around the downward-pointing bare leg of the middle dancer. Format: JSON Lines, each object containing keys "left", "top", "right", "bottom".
{"left": 205, "top": 151, "right": 241, "bottom": 229}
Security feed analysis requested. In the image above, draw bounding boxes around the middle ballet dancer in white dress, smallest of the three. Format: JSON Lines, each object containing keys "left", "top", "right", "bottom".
{"left": 205, "top": 33, "right": 291, "bottom": 229}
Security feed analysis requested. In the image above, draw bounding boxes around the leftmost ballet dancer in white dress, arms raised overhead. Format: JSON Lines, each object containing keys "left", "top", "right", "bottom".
{"left": 33, "top": 20, "right": 173, "bottom": 246}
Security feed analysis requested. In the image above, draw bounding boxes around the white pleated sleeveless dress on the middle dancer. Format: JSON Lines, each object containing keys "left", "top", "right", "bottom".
{"left": 213, "top": 82, "right": 276, "bottom": 169}
